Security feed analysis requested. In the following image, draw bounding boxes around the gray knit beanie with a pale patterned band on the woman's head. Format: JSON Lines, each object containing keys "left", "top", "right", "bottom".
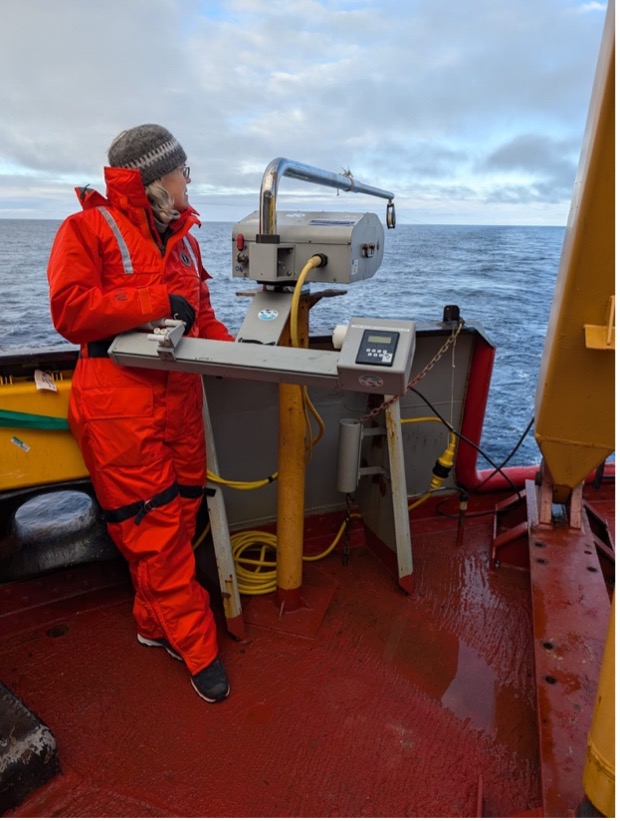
{"left": 108, "top": 123, "right": 187, "bottom": 186}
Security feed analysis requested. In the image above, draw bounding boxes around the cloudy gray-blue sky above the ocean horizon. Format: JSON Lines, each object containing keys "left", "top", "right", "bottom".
{"left": 0, "top": 0, "right": 607, "bottom": 225}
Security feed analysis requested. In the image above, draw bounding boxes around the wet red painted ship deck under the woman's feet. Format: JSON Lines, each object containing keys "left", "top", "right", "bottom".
{"left": 0, "top": 484, "right": 613, "bottom": 817}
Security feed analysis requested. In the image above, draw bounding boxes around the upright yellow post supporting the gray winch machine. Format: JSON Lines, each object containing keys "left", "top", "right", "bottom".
{"left": 276, "top": 301, "right": 309, "bottom": 612}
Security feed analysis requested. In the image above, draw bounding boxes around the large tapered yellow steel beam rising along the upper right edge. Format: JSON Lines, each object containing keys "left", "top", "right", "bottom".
{"left": 535, "top": 2, "right": 616, "bottom": 503}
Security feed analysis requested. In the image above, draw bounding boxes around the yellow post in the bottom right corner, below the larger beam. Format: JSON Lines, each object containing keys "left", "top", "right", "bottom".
{"left": 583, "top": 601, "right": 616, "bottom": 818}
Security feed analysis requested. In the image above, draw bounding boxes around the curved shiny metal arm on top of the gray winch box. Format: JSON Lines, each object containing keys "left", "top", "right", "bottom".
{"left": 258, "top": 157, "right": 394, "bottom": 237}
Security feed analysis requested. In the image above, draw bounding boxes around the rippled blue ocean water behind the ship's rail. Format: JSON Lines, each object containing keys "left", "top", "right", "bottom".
{"left": 0, "top": 215, "right": 564, "bottom": 468}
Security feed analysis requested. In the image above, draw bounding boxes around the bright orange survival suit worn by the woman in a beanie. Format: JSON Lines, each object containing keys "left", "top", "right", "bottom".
{"left": 48, "top": 168, "right": 233, "bottom": 675}
